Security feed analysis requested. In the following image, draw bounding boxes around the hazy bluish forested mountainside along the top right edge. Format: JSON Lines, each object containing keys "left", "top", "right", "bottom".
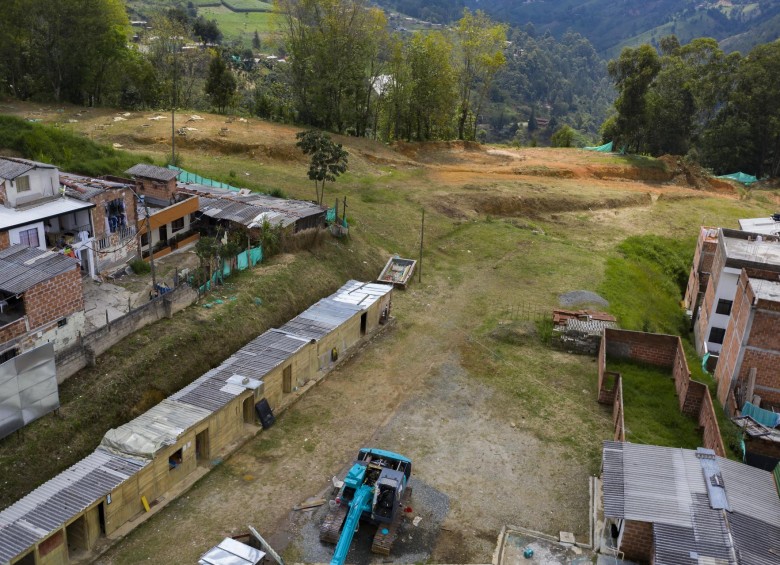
{"left": 377, "top": 0, "right": 780, "bottom": 54}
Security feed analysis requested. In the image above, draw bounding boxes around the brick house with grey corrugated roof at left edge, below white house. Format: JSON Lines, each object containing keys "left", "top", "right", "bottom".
{"left": 0, "top": 245, "right": 85, "bottom": 361}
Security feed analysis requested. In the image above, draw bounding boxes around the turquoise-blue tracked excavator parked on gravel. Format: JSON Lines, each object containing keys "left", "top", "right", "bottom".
{"left": 320, "top": 448, "right": 412, "bottom": 565}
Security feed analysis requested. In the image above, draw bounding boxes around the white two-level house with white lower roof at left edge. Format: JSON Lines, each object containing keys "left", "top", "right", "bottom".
{"left": 0, "top": 157, "right": 96, "bottom": 277}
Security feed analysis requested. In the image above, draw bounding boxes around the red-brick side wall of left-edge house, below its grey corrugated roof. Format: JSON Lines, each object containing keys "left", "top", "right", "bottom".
{"left": 24, "top": 266, "right": 84, "bottom": 330}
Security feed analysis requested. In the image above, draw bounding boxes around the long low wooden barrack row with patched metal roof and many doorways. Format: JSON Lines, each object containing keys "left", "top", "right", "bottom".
{"left": 0, "top": 281, "right": 393, "bottom": 565}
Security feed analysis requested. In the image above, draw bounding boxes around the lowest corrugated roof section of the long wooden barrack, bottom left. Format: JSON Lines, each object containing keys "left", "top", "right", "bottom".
{"left": 0, "top": 449, "right": 148, "bottom": 563}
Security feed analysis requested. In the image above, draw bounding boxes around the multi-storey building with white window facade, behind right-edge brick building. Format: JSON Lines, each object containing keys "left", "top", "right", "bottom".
{"left": 693, "top": 228, "right": 780, "bottom": 356}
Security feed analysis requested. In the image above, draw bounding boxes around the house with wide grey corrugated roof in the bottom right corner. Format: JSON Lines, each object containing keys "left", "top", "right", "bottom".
{"left": 600, "top": 441, "right": 780, "bottom": 565}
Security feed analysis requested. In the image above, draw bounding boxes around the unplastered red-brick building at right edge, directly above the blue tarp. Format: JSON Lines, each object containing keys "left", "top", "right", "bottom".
{"left": 715, "top": 266, "right": 780, "bottom": 415}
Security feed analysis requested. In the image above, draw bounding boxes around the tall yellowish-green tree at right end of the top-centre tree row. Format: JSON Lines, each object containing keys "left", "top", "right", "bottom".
{"left": 455, "top": 8, "right": 508, "bottom": 139}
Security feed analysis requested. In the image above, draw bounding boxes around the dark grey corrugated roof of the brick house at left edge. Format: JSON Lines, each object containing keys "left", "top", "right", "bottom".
{"left": 0, "top": 245, "right": 79, "bottom": 294}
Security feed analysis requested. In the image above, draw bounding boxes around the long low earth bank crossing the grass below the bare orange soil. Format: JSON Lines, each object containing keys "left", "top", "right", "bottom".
{"left": 458, "top": 189, "right": 652, "bottom": 217}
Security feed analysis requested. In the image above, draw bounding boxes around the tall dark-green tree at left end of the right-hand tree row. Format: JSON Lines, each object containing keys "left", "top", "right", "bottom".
{"left": 607, "top": 45, "right": 661, "bottom": 151}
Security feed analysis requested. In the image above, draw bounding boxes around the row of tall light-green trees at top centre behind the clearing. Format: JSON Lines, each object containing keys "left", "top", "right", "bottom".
{"left": 277, "top": 0, "right": 507, "bottom": 139}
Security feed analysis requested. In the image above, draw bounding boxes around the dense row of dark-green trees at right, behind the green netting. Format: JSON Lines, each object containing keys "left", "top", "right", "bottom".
{"left": 603, "top": 36, "right": 780, "bottom": 176}
